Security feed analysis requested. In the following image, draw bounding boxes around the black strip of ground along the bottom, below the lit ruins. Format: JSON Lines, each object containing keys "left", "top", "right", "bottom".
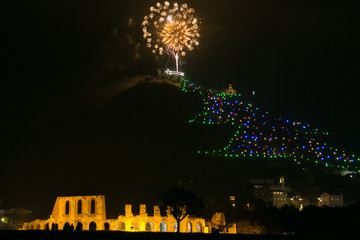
{"left": 0, "top": 230, "right": 356, "bottom": 240}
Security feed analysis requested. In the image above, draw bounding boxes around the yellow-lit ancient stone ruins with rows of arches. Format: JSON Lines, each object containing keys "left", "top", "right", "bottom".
{"left": 22, "top": 195, "right": 236, "bottom": 233}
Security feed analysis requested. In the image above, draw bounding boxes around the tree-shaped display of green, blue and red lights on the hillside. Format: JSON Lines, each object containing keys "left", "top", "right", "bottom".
{"left": 181, "top": 79, "right": 360, "bottom": 173}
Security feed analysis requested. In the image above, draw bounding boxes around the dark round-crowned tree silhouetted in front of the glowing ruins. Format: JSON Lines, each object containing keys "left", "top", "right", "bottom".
{"left": 160, "top": 186, "right": 204, "bottom": 233}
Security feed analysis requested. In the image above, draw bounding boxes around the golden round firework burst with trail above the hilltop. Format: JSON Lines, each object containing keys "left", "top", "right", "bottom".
{"left": 142, "top": 1, "right": 200, "bottom": 74}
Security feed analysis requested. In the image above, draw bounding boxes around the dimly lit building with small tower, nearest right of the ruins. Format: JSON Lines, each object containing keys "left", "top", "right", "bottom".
{"left": 250, "top": 176, "right": 291, "bottom": 208}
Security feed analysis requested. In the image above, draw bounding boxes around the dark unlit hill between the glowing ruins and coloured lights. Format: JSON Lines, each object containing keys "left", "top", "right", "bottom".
{"left": 5, "top": 83, "right": 357, "bottom": 216}
